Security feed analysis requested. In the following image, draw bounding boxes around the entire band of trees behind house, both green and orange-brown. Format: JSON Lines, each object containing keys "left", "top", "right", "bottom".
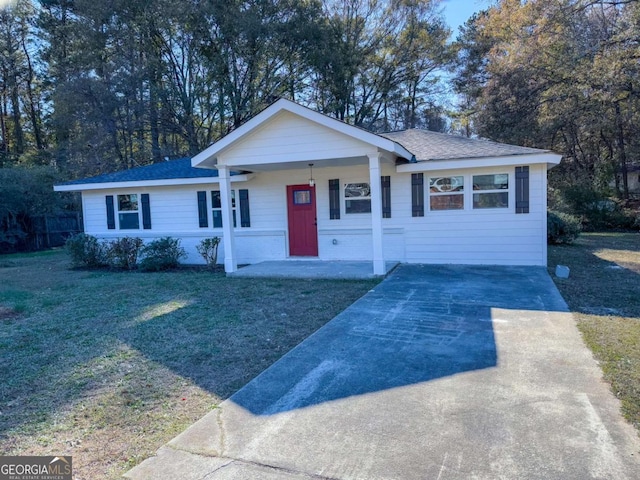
{"left": 0, "top": 0, "right": 640, "bottom": 228}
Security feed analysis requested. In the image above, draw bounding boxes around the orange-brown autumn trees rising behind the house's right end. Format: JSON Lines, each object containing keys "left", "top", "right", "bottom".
{"left": 454, "top": 0, "right": 640, "bottom": 198}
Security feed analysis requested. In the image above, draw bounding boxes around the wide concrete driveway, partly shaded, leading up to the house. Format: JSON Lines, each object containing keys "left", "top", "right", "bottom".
{"left": 126, "top": 265, "right": 640, "bottom": 480}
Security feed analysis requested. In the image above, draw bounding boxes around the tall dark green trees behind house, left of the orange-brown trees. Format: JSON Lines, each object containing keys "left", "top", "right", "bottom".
{"left": 0, "top": 0, "right": 453, "bottom": 177}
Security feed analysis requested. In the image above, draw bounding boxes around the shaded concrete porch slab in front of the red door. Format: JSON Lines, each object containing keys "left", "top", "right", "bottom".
{"left": 227, "top": 259, "right": 398, "bottom": 280}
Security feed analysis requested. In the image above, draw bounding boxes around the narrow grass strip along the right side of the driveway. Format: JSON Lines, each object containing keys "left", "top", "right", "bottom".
{"left": 549, "top": 233, "right": 640, "bottom": 430}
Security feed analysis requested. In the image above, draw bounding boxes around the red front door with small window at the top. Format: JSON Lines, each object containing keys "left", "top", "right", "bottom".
{"left": 287, "top": 185, "right": 318, "bottom": 257}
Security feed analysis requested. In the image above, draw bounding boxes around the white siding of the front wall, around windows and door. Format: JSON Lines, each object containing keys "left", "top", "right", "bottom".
{"left": 83, "top": 161, "right": 546, "bottom": 265}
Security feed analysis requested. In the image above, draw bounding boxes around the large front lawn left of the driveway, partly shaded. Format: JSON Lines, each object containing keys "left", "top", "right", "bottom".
{"left": 0, "top": 251, "right": 375, "bottom": 478}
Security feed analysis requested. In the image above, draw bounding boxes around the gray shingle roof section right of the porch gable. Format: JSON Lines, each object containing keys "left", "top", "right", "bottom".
{"left": 380, "top": 128, "right": 548, "bottom": 161}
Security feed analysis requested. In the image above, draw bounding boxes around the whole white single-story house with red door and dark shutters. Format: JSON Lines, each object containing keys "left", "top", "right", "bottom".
{"left": 55, "top": 99, "right": 561, "bottom": 274}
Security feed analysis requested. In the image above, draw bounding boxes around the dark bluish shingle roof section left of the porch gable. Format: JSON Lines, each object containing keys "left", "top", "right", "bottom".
{"left": 61, "top": 158, "right": 222, "bottom": 185}
